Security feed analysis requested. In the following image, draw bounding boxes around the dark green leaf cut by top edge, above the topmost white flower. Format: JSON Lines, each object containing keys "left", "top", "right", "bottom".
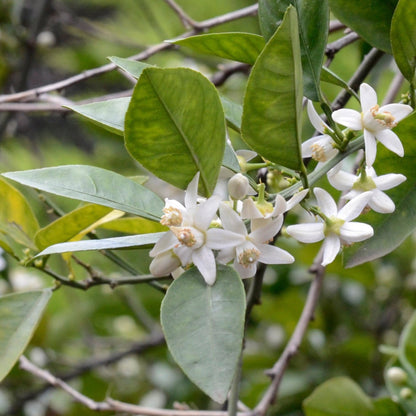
{"left": 329, "top": 0, "right": 398, "bottom": 53}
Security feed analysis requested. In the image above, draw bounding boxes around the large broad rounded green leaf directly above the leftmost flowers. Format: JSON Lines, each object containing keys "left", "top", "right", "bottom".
{"left": 125, "top": 68, "right": 225, "bottom": 195}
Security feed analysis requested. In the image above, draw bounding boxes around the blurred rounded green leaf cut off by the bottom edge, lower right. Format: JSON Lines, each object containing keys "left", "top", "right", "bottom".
{"left": 303, "top": 377, "right": 374, "bottom": 416}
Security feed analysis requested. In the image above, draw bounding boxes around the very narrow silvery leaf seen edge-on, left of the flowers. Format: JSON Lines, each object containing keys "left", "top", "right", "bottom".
{"left": 36, "top": 232, "right": 165, "bottom": 257}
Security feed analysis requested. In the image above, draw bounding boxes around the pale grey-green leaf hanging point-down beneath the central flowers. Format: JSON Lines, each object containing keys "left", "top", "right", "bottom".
{"left": 161, "top": 266, "right": 245, "bottom": 403}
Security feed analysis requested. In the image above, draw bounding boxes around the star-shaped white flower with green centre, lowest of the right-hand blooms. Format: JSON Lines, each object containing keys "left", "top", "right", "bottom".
{"left": 287, "top": 188, "right": 373, "bottom": 266}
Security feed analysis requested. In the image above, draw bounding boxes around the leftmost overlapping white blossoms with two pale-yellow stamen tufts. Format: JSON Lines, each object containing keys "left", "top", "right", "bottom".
{"left": 149, "top": 174, "right": 236, "bottom": 285}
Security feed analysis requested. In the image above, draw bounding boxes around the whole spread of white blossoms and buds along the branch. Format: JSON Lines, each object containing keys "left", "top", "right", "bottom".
{"left": 150, "top": 84, "right": 412, "bottom": 285}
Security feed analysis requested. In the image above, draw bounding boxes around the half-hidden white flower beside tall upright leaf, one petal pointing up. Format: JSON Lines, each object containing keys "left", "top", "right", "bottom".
{"left": 302, "top": 101, "right": 338, "bottom": 165}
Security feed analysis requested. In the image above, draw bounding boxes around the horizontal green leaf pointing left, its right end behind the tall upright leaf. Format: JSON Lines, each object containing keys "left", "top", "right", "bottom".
{"left": 173, "top": 32, "right": 265, "bottom": 65}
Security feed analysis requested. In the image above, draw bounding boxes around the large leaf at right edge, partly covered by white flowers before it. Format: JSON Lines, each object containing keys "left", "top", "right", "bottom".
{"left": 344, "top": 113, "right": 416, "bottom": 267}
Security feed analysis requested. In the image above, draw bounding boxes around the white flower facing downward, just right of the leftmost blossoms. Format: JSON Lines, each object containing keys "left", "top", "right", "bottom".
{"left": 217, "top": 204, "right": 295, "bottom": 279}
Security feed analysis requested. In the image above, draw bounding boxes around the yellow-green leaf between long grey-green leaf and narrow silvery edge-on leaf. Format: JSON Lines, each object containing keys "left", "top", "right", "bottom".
{"left": 35, "top": 204, "right": 112, "bottom": 250}
